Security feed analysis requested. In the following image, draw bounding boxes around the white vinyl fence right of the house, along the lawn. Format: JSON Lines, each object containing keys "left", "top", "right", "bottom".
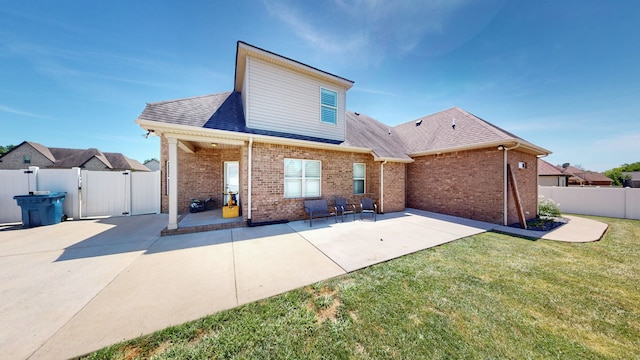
{"left": 538, "top": 186, "right": 640, "bottom": 220}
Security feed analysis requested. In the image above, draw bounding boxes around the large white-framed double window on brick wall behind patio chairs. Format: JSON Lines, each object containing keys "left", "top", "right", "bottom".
{"left": 284, "top": 159, "right": 322, "bottom": 198}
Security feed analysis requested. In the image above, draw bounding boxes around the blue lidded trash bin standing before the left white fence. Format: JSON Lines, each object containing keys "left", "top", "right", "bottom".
{"left": 13, "top": 192, "right": 67, "bottom": 228}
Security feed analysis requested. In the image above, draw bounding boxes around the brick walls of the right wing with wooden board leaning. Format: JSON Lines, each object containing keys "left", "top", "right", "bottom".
{"left": 407, "top": 147, "right": 538, "bottom": 224}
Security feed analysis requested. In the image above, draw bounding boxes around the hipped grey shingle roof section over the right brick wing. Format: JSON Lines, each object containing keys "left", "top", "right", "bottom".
{"left": 393, "top": 107, "right": 549, "bottom": 155}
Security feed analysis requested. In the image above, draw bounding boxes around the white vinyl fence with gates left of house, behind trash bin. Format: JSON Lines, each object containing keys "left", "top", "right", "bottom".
{"left": 0, "top": 167, "right": 160, "bottom": 223}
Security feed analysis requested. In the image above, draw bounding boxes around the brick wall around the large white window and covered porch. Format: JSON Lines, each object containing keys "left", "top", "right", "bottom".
{"left": 160, "top": 137, "right": 405, "bottom": 222}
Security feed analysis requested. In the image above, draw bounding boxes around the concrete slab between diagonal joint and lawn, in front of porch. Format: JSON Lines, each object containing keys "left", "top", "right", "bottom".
{"left": 31, "top": 230, "right": 238, "bottom": 359}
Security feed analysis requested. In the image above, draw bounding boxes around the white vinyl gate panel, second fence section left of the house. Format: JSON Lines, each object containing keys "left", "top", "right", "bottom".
{"left": 80, "top": 170, "right": 131, "bottom": 218}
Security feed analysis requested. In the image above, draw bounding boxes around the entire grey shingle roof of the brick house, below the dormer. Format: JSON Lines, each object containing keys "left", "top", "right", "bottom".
{"left": 139, "top": 92, "right": 544, "bottom": 160}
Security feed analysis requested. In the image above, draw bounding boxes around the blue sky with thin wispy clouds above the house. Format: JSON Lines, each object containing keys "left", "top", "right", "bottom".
{"left": 0, "top": 0, "right": 640, "bottom": 171}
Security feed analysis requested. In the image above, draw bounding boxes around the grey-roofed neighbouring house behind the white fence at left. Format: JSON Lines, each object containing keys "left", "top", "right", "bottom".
{"left": 0, "top": 141, "right": 150, "bottom": 171}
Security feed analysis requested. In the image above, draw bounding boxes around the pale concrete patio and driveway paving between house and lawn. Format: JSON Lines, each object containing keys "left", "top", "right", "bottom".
{"left": 0, "top": 209, "right": 606, "bottom": 359}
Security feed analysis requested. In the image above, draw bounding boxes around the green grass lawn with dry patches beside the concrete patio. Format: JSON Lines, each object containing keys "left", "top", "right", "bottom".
{"left": 81, "top": 218, "right": 640, "bottom": 359}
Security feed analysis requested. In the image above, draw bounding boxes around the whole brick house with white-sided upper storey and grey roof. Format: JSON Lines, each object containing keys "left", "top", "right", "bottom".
{"left": 136, "top": 41, "right": 549, "bottom": 229}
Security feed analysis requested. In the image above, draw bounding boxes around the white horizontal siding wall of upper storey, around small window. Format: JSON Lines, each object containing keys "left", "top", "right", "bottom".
{"left": 243, "top": 58, "right": 345, "bottom": 141}
